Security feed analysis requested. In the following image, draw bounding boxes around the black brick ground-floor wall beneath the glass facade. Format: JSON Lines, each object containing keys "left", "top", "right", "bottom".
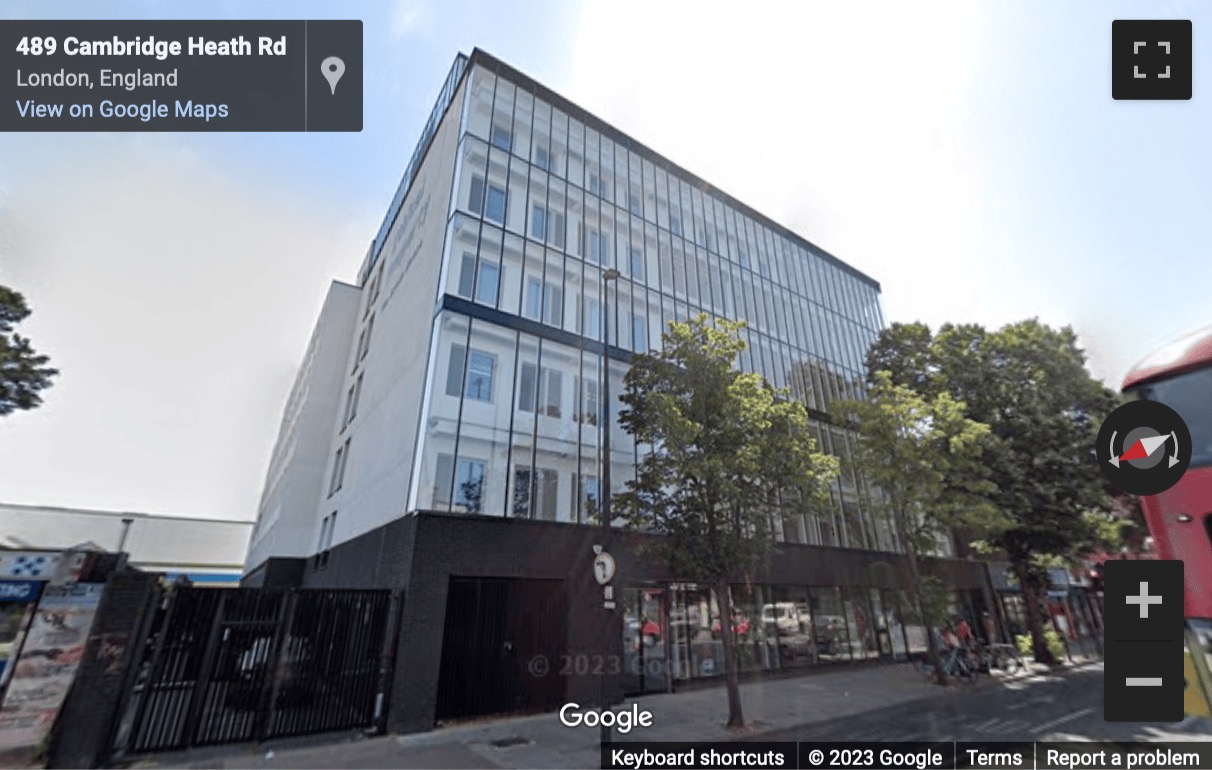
{"left": 295, "top": 513, "right": 985, "bottom": 732}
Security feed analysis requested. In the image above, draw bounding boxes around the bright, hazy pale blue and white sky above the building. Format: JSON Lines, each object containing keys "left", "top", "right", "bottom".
{"left": 0, "top": 0, "right": 1212, "bottom": 520}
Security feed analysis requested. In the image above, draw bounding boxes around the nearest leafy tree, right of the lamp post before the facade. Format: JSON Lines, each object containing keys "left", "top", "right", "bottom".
{"left": 618, "top": 314, "right": 837, "bottom": 728}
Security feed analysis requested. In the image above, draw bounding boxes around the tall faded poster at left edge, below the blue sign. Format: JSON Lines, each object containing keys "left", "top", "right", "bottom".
{"left": 0, "top": 583, "right": 104, "bottom": 752}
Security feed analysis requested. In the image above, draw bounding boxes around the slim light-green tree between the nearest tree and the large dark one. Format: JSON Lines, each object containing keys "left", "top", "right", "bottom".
{"left": 830, "top": 371, "right": 1005, "bottom": 684}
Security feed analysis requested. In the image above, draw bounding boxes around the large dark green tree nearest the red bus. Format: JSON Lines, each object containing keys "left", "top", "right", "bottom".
{"left": 868, "top": 319, "right": 1116, "bottom": 663}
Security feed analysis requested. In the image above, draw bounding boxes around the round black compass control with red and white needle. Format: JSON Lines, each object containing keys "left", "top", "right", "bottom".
{"left": 1094, "top": 401, "right": 1191, "bottom": 495}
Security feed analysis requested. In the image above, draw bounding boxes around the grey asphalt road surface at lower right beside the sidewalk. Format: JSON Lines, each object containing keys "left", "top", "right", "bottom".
{"left": 760, "top": 663, "right": 1212, "bottom": 741}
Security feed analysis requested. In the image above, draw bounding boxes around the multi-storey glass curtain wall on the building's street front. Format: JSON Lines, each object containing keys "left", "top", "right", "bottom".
{"left": 408, "top": 62, "right": 896, "bottom": 555}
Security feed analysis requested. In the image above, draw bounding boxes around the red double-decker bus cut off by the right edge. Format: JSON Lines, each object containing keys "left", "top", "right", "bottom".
{"left": 1124, "top": 326, "right": 1212, "bottom": 717}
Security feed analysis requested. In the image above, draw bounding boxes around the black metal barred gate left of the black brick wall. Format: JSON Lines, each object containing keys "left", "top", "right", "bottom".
{"left": 107, "top": 587, "right": 399, "bottom": 755}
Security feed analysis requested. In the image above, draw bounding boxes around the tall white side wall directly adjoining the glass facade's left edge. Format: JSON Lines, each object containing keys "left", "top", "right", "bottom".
{"left": 312, "top": 76, "right": 463, "bottom": 555}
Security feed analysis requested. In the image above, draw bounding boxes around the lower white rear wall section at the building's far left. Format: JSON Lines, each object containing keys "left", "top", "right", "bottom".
{"left": 245, "top": 281, "right": 362, "bottom": 571}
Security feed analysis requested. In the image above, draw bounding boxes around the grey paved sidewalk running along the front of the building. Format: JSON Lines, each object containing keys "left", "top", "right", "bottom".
{"left": 132, "top": 663, "right": 1100, "bottom": 770}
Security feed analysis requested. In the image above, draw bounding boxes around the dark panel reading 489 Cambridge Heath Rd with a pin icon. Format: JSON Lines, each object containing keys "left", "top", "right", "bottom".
{"left": 0, "top": 21, "right": 364, "bottom": 131}
